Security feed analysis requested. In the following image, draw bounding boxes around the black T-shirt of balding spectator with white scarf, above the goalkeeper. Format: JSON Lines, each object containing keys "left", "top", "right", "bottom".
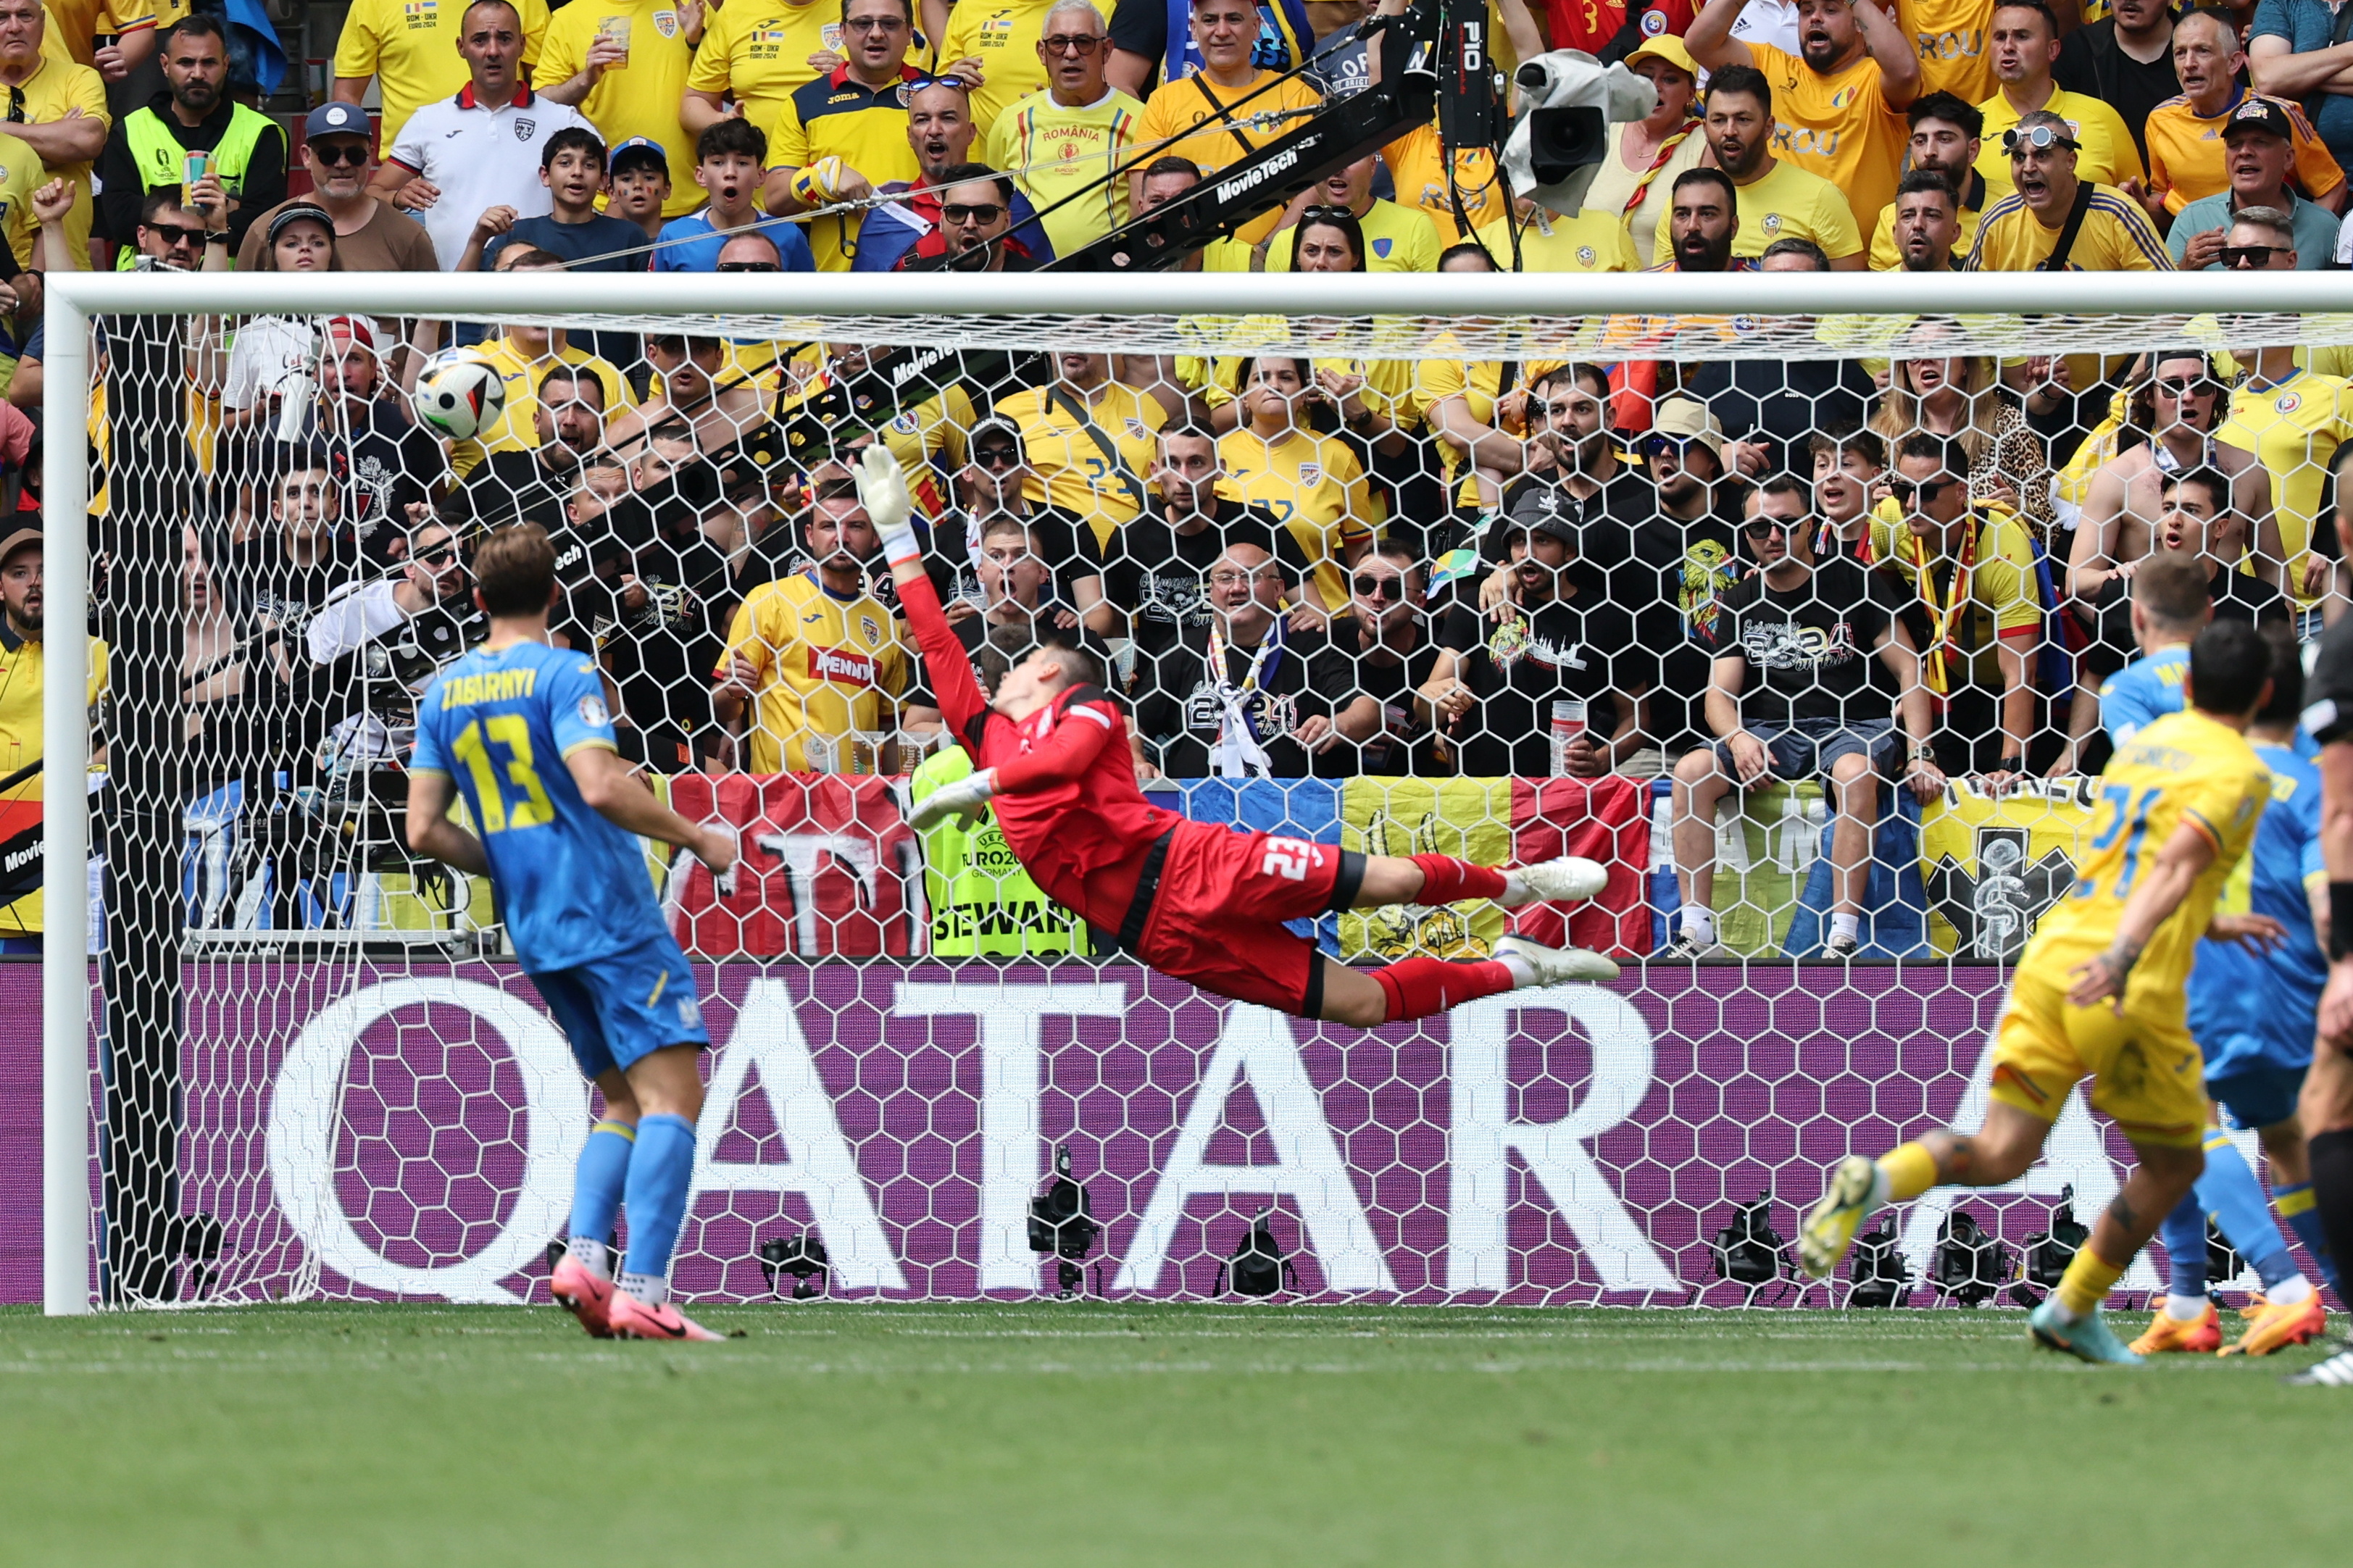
{"left": 1136, "top": 626, "right": 1334, "bottom": 780}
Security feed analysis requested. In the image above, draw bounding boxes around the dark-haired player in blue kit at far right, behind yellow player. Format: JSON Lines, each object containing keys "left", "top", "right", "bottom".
{"left": 2132, "top": 629, "right": 2344, "bottom": 1356}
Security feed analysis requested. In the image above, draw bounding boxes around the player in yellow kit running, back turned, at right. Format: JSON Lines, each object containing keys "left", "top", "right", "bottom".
{"left": 1798, "top": 622, "right": 2280, "bottom": 1366}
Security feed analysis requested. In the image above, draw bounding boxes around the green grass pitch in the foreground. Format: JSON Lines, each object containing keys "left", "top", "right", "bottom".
{"left": 0, "top": 1302, "right": 2353, "bottom": 1568}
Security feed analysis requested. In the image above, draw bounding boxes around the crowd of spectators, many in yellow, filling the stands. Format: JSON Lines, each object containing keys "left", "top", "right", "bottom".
{"left": 18, "top": 0, "right": 2353, "bottom": 937}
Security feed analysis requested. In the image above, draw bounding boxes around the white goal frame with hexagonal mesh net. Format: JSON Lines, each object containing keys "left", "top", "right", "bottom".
{"left": 32, "top": 273, "right": 2353, "bottom": 1311}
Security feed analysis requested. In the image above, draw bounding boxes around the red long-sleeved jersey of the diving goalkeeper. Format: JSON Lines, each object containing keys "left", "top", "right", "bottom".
{"left": 899, "top": 564, "right": 1183, "bottom": 909}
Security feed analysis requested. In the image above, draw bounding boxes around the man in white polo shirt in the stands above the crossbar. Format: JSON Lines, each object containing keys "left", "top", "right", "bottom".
{"left": 367, "top": 0, "right": 595, "bottom": 273}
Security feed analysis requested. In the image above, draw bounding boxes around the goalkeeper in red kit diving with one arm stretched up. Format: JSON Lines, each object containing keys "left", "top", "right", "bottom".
{"left": 857, "top": 445, "right": 1617, "bottom": 1029}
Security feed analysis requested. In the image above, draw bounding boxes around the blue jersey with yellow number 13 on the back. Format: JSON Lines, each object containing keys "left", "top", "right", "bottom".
{"left": 409, "top": 643, "right": 664, "bottom": 975}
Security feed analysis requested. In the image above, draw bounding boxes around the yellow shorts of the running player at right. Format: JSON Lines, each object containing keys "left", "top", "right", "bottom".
{"left": 1993, "top": 970, "right": 2207, "bottom": 1149}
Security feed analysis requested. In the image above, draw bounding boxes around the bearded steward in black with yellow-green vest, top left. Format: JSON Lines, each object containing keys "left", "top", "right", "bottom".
{"left": 92, "top": 14, "right": 291, "bottom": 268}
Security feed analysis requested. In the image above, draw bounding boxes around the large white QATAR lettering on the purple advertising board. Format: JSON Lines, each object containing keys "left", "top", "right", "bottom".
{"left": 268, "top": 975, "right": 1680, "bottom": 1302}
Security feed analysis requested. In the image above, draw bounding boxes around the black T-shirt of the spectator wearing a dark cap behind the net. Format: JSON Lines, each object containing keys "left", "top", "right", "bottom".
{"left": 1438, "top": 579, "right": 1654, "bottom": 777}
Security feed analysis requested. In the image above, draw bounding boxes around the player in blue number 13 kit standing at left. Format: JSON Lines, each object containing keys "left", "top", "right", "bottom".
{"left": 409, "top": 522, "right": 736, "bottom": 1340}
